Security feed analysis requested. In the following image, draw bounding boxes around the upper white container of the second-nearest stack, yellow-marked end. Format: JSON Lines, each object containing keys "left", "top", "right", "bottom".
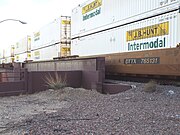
{"left": 31, "top": 16, "right": 71, "bottom": 50}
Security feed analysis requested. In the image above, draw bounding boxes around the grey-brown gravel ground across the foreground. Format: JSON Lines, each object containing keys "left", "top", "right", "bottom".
{"left": 0, "top": 82, "right": 180, "bottom": 135}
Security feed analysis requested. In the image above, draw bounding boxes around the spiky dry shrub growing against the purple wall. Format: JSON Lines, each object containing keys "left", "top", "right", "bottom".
{"left": 45, "top": 72, "right": 67, "bottom": 90}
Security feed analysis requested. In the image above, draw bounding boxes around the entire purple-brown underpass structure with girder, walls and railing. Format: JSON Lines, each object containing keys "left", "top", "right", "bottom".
{"left": 0, "top": 57, "right": 131, "bottom": 96}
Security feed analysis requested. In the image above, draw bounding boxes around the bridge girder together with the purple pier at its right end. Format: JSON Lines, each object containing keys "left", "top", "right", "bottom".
{"left": 23, "top": 57, "right": 105, "bottom": 92}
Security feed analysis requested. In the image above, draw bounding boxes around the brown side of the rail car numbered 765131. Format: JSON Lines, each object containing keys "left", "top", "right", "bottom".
{"left": 105, "top": 48, "right": 180, "bottom": 76}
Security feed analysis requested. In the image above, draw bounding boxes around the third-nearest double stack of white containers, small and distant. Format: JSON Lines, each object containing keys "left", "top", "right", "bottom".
{"left": 14, "top": 36, "right": 31, "bottom": 62}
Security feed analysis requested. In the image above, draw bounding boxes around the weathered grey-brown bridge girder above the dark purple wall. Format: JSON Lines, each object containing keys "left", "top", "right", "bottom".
{"left": 23, "top": 57, "right": 105, "bottom": 71}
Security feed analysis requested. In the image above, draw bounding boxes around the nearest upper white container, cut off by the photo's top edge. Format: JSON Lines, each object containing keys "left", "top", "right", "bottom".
{"left": 71, "top": 0, "right": 180, "bottom": 39}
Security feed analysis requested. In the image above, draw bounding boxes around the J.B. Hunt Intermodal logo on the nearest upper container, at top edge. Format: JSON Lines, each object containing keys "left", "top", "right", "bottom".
{"left": 82, "top": 0, "right": 102, "bottom": 21}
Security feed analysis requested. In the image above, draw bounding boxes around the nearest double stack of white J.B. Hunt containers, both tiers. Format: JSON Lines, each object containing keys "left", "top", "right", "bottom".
{"left": 71, "top": 0, "right": 180, "bottom": 56}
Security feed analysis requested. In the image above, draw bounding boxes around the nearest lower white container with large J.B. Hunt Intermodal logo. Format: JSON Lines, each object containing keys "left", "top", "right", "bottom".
{"left": 71, "top": 11, "right": 180, "bottom": 56}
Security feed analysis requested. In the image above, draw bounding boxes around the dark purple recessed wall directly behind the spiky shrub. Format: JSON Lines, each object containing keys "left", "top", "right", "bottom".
{"left": 28, "top": 71, "right": 82, "bottom": 93}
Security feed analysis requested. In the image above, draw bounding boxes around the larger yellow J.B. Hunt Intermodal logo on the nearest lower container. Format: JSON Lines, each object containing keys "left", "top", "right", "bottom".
{"left": 126, "top": 22, "right": 169, "bottom": 51}
